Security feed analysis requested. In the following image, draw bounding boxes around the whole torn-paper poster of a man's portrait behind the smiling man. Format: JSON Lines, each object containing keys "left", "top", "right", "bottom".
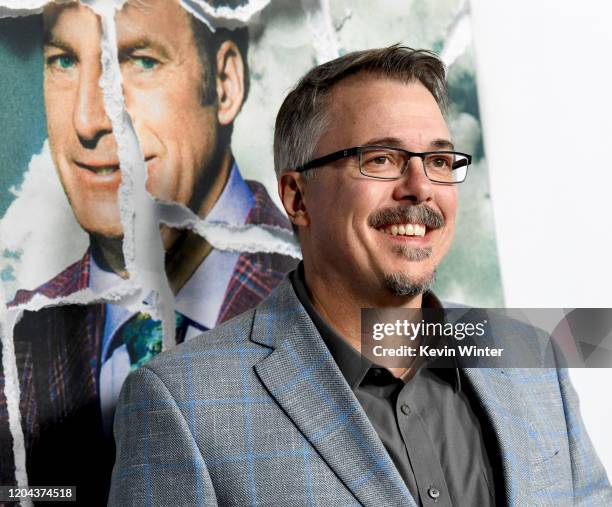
{"left": 0, "top": 0, "right": 503, "bottom": 500}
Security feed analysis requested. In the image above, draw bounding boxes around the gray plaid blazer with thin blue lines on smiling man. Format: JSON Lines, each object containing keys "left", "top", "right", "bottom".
{"left": 109, "top": 281, "right": 612, "bottom": 507}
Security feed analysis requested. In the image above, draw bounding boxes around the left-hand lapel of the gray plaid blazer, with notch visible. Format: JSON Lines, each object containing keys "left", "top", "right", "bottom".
{"left": 251, "top": 281, "right": 416, "bottom": 507}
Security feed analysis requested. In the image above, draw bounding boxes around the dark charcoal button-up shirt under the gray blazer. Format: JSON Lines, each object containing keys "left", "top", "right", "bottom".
{"left": 289, "top": 264, "right": 505, "bottom": 507}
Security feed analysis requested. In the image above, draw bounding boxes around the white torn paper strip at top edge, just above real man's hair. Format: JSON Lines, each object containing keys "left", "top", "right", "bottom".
{"left": 301, "top": 0, "right": 340, "bottom": 65}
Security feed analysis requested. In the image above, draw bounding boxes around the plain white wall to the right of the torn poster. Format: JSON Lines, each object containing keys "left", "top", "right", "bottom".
{"left": 470, "top": 0, "right": 612, "bottom": 475}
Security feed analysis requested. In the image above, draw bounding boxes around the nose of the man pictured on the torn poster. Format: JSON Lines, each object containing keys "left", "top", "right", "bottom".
{"left": 73, "top": 68, "right": 113, "bottom": 149}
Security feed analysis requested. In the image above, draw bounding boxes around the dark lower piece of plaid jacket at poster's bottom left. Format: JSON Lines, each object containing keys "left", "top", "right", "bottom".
{"left": 0, "top": 304, "right": 113, "bottom": 505}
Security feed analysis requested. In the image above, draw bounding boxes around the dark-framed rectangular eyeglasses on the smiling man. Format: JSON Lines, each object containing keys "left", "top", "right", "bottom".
{"left": 295, "top": 146, "right": 472, "bottom": 183}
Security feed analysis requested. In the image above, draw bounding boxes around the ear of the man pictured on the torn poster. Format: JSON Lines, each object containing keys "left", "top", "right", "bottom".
{"left": 216, "top": 40, "right": 244, "bottom": 125}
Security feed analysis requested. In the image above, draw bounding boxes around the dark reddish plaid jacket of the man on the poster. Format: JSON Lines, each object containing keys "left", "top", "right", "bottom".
{"left": 0, "top": 177, "right": 295, "bottom": 503}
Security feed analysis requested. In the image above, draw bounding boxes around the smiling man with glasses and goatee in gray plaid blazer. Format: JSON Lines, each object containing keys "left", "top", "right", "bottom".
{"left": 110, "top": 46, "right": 612, "bottom": 507}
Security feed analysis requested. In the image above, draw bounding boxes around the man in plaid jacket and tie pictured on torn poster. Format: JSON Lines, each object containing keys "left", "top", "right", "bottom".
{"left": 0, "top": 0, "right": 295, "bottom": 502}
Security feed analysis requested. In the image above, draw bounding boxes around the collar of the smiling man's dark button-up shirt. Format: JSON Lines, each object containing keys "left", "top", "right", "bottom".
{"left": 289, "top": 262, "right": 461, "bottom": 391}
